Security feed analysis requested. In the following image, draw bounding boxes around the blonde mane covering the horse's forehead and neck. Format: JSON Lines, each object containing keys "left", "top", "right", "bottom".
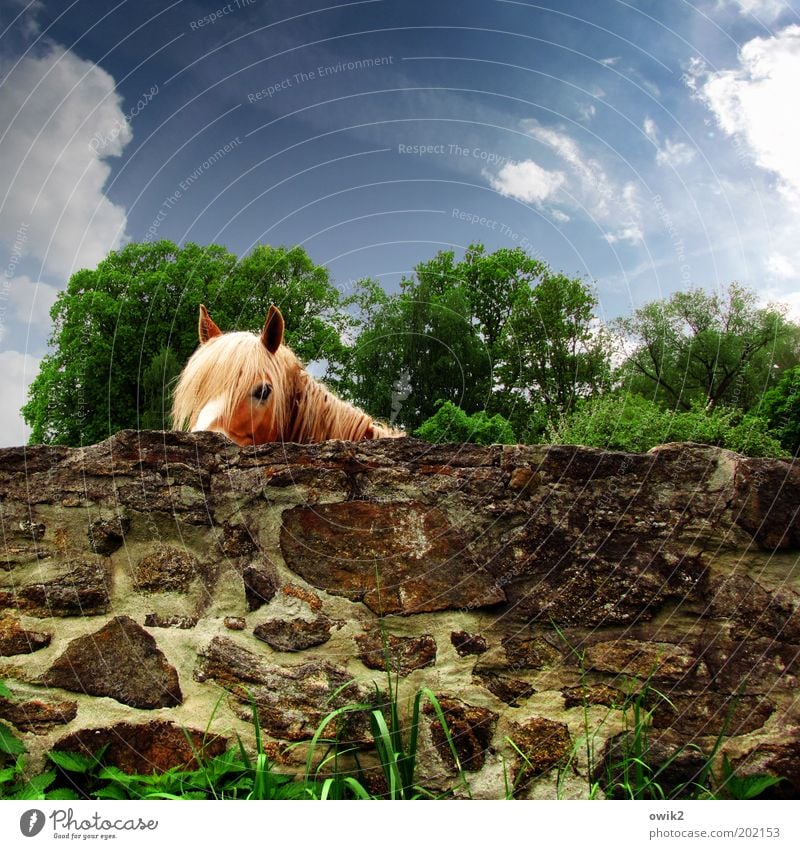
{"left": 172, "top": 322, "right": 404, "bottom": 443}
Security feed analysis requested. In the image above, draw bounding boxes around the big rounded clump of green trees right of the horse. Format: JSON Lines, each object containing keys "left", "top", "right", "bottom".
{"left": 352, "top": 245, "right": 610, "bottom": 431}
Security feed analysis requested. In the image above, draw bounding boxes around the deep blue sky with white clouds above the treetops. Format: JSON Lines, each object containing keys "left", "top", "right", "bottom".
{"left": 0, "top": 0, "right": 800, "bottom": 445}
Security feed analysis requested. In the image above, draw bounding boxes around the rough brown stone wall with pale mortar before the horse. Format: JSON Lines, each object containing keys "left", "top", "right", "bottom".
{"left": 0, "top": 431, "right": 800, "bottom": 798}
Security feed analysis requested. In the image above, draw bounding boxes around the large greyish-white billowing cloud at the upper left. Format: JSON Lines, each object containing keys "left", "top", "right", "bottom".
{"left": 0, "top": 45, "right": 131, "bottom": 279}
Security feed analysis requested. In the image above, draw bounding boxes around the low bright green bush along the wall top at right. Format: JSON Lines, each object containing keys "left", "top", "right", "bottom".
{"left": 548, "top": 392, "right": 786, "bottom": 457}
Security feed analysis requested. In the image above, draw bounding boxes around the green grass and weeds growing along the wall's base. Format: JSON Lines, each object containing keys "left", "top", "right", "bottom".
{"left": 0, "top": 656, "right": 782, "bottom": 800}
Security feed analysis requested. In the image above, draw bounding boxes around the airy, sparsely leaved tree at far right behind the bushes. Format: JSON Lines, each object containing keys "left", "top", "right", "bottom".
{"left": 616, "top": 283, "right": 800, "bottom": 410}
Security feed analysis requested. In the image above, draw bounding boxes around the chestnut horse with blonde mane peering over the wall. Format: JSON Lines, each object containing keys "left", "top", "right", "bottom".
{"left": 172, "top": 304, "right": 405, "bottom": 445}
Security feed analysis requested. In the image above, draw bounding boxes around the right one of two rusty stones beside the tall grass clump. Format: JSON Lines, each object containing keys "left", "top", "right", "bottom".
{"left": 422, "top": 693, "right": 500, "bottom": 772}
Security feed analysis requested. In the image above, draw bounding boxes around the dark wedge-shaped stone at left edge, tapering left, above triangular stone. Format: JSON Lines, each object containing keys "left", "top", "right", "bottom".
{"left": 0, "top": 555, "right": 111, "bottom": 617}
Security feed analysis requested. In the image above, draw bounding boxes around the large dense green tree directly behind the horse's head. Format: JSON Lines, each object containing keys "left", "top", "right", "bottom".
{"left": 22, "top": 241, "right": 349, "bottom": 445}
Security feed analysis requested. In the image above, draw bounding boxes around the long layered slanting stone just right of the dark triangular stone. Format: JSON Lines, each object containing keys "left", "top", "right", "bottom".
{"left": 195, "top": 637, "right": 372, "bottom": 742}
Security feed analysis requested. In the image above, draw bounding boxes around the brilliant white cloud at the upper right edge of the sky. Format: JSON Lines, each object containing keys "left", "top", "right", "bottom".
{"left": 697, "top": 26, "right": 800, "bottom": 207}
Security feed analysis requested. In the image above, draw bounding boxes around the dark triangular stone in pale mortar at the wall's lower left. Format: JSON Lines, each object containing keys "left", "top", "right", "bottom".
{"left": 40, "top": 616, "right": 183, "bottom": 710}
